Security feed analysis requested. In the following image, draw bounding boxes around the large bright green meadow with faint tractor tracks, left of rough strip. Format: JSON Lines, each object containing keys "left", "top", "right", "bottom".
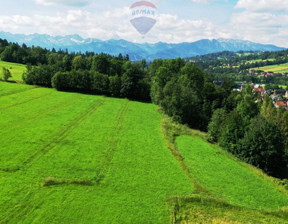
{"left": 0, "top": 82, "right": 194, "bottom": 223}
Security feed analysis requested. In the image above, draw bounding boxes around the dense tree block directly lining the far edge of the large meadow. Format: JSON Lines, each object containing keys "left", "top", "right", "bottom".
{"left": 23, "top": 53, "right": 150, "bottom": 101}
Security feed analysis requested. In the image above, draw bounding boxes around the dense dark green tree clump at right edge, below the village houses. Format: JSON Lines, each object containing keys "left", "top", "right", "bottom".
{"left": 208, "top": 85, "right": 288, "bottom": 178}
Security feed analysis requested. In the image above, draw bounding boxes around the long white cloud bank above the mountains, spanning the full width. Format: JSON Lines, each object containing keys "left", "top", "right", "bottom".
{"left": 0, "top": 0, "right": 288, "bottom": 46}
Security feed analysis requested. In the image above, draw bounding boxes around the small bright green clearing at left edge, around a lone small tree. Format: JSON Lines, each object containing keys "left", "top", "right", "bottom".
{"left": 0, "top": 61, "right": 26, "bottom": 82}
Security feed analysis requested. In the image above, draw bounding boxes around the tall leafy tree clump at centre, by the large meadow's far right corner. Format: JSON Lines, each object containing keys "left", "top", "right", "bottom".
{"left": 149, "top": 59, "right": 231, "bottom": 130}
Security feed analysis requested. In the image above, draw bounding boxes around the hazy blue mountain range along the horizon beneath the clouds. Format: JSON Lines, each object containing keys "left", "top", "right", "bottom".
{"left": 0, "top": 32, "right": 285, "bottom": 61}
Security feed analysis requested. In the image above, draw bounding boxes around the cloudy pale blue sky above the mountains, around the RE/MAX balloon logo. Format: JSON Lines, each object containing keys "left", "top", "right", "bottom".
{"left": 0, "top": 0, "right": 288, "bottom": 47}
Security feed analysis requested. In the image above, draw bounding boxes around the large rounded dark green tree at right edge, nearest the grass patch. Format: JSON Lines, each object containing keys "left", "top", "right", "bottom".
{"left": 238, "top": 115, "right": 287, "bottom": 177}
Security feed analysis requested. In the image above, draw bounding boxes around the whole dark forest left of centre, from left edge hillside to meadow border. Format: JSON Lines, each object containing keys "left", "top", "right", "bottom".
{"left": 0, "top": 39, "right": 150, "bottom": 101}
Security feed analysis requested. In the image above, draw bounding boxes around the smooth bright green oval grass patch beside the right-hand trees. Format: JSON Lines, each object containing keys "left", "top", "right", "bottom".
{"left": 176, "top": 136, "right": 288, "bottom": 209}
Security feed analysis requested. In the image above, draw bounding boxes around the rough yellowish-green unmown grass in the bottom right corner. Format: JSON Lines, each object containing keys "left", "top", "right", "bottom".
{"left": 174, "top": 195, "right": 288, "bottom": 224}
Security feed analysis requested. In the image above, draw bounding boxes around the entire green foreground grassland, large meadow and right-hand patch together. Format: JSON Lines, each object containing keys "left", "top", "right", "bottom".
{"left": 0, "top": 82, "right": 288, "bottom": 224}
